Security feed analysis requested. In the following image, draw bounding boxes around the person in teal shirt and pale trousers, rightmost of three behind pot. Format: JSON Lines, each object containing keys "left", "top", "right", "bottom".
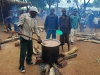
{"left": 70, "top": 10, "right": 80, "bottom": 45}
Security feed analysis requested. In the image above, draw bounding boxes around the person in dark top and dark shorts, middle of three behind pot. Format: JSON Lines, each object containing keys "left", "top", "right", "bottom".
{"left": 59, "top": 9, "right": 71, "bottom": 51}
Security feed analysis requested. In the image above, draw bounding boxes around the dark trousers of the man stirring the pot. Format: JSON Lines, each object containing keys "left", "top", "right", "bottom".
{"left": 19, "top": 37, "right": 33, "bottom": 67}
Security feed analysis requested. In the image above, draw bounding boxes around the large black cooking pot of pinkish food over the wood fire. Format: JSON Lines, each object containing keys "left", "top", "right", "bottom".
{"left": 42, "top": 39, "right": 60, "bottom": 64}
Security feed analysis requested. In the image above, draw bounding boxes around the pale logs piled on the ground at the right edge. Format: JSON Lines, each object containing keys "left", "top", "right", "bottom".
{"left": 76, "top": 33, "right": 100, "bottom": 44}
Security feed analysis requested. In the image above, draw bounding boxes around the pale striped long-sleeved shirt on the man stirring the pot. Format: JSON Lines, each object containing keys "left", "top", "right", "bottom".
{"left": 18, "top": 13, "right": 39, "bottom": 40}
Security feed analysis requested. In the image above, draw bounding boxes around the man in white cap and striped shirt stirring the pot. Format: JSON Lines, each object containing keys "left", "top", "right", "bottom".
{"left": 18, "top": 6, "right": 40, "bottom": 73}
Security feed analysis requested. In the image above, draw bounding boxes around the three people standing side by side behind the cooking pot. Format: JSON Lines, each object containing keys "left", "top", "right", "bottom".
{"left": 44, "top": 8, "right": 80, "bottom": 50}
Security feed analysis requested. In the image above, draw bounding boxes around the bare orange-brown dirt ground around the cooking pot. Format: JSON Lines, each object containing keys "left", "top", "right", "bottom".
{"left": 0, "top": 18, "right": 100, "bottom": 75}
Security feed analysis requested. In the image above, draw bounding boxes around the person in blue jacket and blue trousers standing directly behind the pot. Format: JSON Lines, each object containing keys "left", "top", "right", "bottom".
{"left": 44, "top": 8, "right": 58, "bottom": 39}
